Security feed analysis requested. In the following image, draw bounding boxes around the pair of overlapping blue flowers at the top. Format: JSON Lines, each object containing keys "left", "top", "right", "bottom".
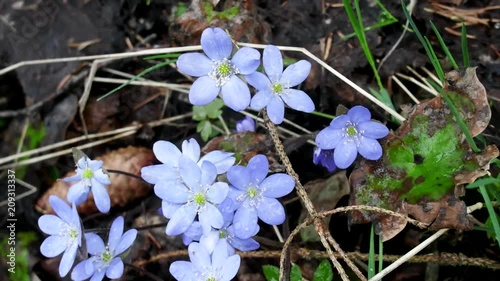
{"left": 177, "top": 28, "right": 315, "bottom": 124}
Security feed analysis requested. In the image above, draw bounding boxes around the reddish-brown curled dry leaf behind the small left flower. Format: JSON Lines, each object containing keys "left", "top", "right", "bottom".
{"left": 35, "top": 146, "right": 155, "bottom": 215}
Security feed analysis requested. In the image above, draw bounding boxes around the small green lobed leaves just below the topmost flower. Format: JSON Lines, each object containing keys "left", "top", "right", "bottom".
{"left": 193, "top": 99, "right": 224, "bottom": 141}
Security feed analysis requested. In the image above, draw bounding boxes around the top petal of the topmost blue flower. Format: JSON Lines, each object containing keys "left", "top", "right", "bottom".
{"left": 201, "top": 27, "right": 233, "bottom": 60}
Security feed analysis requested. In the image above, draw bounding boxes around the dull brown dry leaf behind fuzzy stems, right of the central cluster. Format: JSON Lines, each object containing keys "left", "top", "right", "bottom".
{"left": 299, "top": 171, "right": 349, "bottom": 242}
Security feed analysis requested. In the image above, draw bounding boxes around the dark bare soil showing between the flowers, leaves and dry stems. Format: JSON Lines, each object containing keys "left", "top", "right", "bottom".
{"left": 0, "top": 0, "right": 500, "bottom": 280}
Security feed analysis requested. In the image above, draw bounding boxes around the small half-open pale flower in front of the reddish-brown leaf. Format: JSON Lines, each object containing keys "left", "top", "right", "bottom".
{"left": 62, "top": 157, "right": 111, "bottom": 213}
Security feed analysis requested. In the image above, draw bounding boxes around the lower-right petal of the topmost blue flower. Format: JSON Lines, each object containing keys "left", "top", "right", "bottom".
{"left": 222, "top": 75, "right": 250, "bottom": 111}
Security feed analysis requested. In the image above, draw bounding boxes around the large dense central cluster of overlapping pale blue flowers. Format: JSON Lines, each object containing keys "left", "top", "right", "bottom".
{"left": 141, "top": 139, "right": 295, "bottom": 280}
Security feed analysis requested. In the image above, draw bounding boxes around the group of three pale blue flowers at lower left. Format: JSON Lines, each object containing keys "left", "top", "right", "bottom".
{"left": 38, "top": 151, "right": 137, "bottom": 281}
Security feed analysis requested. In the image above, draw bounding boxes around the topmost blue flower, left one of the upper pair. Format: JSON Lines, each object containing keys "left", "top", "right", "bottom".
{"left": 177, "top": 28, "right": 260, "bottom": 111}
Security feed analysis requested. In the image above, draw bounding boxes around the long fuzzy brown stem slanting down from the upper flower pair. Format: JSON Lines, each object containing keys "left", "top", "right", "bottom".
{"left": 262, "top": 109, "right": 366, "bottom": 281}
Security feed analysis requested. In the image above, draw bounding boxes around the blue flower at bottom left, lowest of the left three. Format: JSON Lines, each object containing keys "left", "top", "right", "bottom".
{"left": 71, "top": 217, "right": 137, "bottom": 281}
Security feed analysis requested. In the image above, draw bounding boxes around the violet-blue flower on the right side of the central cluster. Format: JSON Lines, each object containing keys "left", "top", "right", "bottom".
{"left": 227, "top": 154, "right": 295, "bottom": 239}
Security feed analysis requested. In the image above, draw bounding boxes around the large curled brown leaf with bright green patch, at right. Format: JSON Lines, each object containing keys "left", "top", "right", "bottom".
{"left": 349, "top": 68, "right": 499, "bottom": 241}
